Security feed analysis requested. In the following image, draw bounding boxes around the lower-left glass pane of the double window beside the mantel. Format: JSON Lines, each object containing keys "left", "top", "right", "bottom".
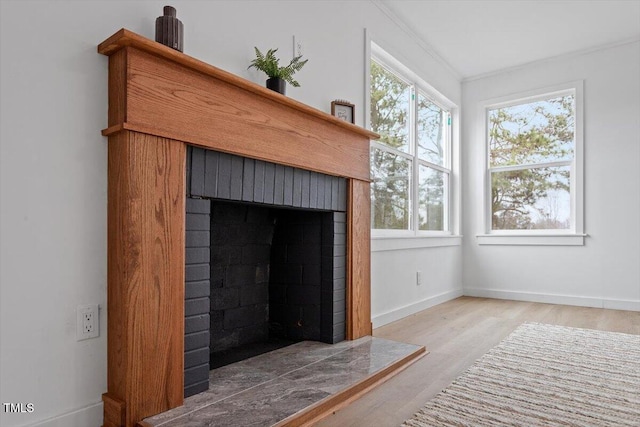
{"left": 371, "top": 148, "right": 411, "bottom": 230}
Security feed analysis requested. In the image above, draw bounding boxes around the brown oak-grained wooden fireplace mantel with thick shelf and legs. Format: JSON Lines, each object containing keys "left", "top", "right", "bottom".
{"left": 98, "top": 29, "right": 378, "bottom": 427}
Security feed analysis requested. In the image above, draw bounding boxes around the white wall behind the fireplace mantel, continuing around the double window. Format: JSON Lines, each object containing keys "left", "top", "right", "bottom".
{"left": 0, "top": 0, "right": 461, "bottom": 427}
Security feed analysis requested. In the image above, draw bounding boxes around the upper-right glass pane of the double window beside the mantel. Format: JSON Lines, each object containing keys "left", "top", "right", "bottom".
{"left": 418, "top": 94, "right": 448, "bottom": 166}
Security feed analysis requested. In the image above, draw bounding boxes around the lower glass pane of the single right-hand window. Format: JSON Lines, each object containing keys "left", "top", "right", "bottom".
{"left": 491, "top": 166, "right": 571, "bottom": 230}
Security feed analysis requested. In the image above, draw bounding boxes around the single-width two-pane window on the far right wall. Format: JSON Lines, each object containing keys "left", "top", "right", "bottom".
{"left": 485, "top": 85, "right": 582, "bottom": 246}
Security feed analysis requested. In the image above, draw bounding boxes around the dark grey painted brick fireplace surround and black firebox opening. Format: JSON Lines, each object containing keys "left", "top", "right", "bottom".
{"left": 185, "top": 148, "right": 346, "bottom": 397}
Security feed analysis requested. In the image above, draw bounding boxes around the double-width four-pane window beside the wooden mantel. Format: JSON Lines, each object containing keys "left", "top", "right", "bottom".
{"left": 370, "top": 48, "right": 451, "bottom": 235}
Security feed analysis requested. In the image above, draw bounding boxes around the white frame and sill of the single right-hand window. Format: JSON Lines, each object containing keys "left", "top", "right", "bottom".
{"left": 476, "top": 80, "right": 587, "bottom": 246}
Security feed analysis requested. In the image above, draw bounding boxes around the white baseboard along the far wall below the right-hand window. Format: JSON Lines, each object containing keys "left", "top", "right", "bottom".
{"left": 464, "top": 288, "right": 640, "bottom": 311}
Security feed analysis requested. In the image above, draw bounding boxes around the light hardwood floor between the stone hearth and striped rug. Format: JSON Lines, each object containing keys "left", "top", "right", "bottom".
{"left": 316, "top": 297, "right": 640, "bottom": 427}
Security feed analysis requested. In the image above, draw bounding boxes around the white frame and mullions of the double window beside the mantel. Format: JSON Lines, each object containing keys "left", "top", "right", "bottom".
{"left": 365, "top": 41, "right": 460, "bottom": 250}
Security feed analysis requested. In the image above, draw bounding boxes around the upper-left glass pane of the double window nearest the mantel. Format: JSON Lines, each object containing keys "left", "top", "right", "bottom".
{"left": 371, "top": 61, "right": 411, "bottom": 153}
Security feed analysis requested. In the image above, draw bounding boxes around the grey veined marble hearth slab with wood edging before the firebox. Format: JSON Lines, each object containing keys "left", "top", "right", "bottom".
{"left": 145, "top": 336, "right": 424, "bottom": 427}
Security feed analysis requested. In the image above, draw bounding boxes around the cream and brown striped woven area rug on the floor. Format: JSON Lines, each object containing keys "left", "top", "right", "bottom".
{"left": 402, "top": 323, "right": 640, "bottom": 427}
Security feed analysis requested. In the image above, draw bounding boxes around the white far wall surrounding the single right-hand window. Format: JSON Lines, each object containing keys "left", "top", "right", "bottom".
{"left": 463, "top": 42, "right": 640, "bottom": 310}
